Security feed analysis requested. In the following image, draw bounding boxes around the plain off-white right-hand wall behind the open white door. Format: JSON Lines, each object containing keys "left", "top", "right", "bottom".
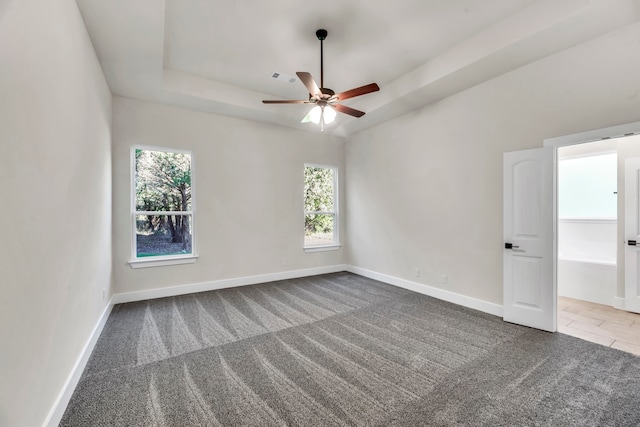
{"left": 345, "top": 23, "right": 640, "bottom": 304}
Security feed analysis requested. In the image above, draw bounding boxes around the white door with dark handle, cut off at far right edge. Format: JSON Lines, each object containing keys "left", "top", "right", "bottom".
{"left": 624, "top": 157, "right": 640, "bottom": 313}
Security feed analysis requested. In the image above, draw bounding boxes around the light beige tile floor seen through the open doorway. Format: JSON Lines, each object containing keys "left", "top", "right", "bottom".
{"left": 558, "top": 296, "right": 640, "bottom": 355}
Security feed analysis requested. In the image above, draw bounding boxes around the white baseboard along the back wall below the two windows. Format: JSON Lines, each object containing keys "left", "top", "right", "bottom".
{"left": 111, "top": 264, "right": 347, "bottom": 304}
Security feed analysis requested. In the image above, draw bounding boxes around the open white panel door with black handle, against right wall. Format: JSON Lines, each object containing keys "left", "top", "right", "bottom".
{"left": 503, "top": 147, "right": 556, "bottom": 332}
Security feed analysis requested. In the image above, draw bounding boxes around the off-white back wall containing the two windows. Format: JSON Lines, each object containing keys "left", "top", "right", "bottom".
{"left": 113, "top": 97, "right": 346, "bottom": 293}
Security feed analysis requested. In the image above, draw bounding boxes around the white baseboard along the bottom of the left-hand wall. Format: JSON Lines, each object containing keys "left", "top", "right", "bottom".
{"left": 43, "top": 298, "right": 113, "bottom": 427}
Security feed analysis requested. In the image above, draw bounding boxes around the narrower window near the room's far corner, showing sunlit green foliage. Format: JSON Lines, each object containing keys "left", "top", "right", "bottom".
{"left": 304, "top": 165, "right": 338, "bottom": 248}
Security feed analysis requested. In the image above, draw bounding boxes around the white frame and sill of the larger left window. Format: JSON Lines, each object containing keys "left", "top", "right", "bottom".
{"left": 129, "top": 145, "right": 198, "bottom": 268}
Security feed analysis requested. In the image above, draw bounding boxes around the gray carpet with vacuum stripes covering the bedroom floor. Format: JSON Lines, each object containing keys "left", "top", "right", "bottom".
{"left": 60, "top": 273, "right": 640, "bottom": 427}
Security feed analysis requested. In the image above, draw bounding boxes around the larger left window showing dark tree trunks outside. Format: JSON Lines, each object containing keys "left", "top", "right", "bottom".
{"left": 131, "top": 147, "right": 195, "bottom": 267}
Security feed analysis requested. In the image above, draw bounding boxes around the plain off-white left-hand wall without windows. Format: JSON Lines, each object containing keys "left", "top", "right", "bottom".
{"left": 0, "top": 0, "right": 111, "bottom": 427}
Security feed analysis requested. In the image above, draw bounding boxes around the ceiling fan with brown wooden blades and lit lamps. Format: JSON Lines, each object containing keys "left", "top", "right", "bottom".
{"left": 262, "top": 29, "right": 380, "bottom": 130}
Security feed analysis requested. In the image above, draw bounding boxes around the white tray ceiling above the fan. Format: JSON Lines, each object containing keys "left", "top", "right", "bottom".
{"left": 77, "top": 0, "right": 640, "bottom": 136}
